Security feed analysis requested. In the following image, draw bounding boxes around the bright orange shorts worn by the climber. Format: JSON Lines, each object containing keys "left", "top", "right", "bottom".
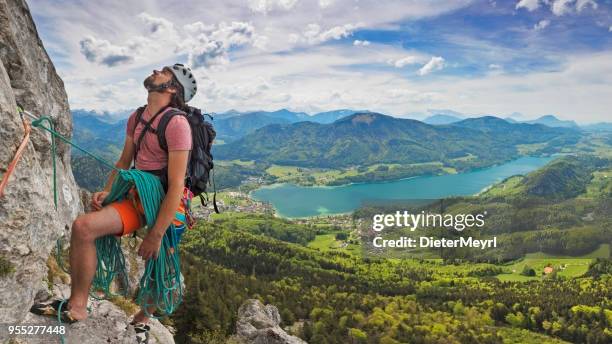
{"left": 109, "top": 188, "right": 192, "bottom": 236}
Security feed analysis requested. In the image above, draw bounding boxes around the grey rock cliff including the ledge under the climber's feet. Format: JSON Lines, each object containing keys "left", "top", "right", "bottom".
{"left": 0, "top": 0, "right": 174, "bottom": 344}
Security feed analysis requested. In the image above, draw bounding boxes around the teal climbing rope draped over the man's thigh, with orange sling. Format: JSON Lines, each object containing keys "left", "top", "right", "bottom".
{"left": 0, "top": 106, "right": 183, "bottom": 343}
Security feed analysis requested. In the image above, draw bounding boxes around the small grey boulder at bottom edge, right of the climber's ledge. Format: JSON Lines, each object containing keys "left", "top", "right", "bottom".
{"left": 235, "top": 299, "right": 306, "bottom": 344}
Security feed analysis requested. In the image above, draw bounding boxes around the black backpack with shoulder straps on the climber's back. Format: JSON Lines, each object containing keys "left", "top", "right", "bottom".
{"left": 134, "top": 106, "right": 219, "bottom": 213}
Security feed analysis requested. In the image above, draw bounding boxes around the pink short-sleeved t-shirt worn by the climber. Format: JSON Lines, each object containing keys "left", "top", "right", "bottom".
{"left": 126, "top": 107, "right": 191, "bottom": 171}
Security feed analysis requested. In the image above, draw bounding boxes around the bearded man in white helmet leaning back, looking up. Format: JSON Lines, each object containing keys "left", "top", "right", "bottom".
{"left": 31, "top": 64, "right": 197, "bottom": 340}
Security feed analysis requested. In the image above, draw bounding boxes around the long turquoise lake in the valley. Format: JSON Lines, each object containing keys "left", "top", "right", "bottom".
{"left": 251, "top": 157, "right": 553, "bottom": 217}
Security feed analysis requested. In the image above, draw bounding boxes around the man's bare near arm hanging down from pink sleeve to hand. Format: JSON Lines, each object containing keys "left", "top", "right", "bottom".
{"left": 138, "top": 150, "right": 189, "bottom": 259}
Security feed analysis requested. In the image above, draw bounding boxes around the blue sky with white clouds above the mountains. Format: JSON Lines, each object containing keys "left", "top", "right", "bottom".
{"left": 29, "top": 0, "right": 612, "bottom": 123}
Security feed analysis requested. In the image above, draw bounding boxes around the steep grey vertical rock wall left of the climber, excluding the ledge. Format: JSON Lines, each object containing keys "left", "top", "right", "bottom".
{"left": 0, "top": 0, "right": 81, "bottom": 332}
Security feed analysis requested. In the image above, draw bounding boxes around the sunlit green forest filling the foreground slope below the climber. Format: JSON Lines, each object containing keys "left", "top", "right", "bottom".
{"left": 172, "top": 217, "right": 612, "bottom": 343}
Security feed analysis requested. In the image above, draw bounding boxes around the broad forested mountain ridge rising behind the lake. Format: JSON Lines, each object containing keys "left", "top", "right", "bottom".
{"left": 215, "top": 113, "right": 580, "bottom": 169}
